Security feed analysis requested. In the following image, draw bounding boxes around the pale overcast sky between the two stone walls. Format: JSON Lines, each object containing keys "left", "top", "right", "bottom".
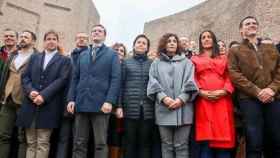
{"left": 93, "top": 0, "right": 205, "bottom": 50}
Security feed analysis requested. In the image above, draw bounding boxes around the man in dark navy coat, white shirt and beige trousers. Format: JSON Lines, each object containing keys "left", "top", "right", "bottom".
{"left": 17, "top": 31, "right": 71, "bottom": 158}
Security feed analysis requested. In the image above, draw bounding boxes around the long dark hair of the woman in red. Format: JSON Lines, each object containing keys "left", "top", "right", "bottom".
{"left": 199, "top": 30, "right": 220, "bottom": 58}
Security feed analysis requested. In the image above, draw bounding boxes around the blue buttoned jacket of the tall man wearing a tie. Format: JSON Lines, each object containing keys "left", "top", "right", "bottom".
{"left": 68, "top": 44, "right": 121, "bottom": 112}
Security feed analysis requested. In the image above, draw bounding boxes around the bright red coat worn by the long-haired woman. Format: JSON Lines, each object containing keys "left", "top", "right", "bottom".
{"left": 192, "top": 54, "right": 235, "bottom": 148}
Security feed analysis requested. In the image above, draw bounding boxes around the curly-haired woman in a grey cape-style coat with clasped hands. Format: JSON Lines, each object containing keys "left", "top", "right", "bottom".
{"left": 147, "top": 33, "right": 198, "bottom": 158}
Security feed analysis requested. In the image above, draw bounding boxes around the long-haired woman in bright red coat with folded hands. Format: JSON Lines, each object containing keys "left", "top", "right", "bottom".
{"left": 192, "top": 31, "right": 235, "bottom": 158}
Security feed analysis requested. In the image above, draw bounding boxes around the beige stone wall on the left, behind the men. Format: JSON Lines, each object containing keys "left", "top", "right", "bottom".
{"left": 0, "top": 0, "right": 100, "bottom": 52}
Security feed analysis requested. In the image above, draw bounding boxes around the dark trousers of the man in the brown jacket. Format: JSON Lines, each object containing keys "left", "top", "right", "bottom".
{"left": 240, "top": 99, "right": 280, "bottom": 158}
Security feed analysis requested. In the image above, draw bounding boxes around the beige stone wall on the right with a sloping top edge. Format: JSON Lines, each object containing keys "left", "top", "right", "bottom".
{"left": 144, "top": 0, "right": 280, "bottom": 49}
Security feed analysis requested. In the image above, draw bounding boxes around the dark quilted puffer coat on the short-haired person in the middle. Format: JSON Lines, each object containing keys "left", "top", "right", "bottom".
{"left": 120, "top": 55, "right": 154, "bottom": 120}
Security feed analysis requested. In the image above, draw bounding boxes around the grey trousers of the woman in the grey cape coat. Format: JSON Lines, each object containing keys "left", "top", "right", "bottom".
{"left": 159, "top": 125, "right": 191, "bottom": 158}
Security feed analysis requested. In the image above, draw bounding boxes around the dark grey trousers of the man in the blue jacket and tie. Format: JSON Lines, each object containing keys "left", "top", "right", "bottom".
{"left": 72, "top": 113, "right": 110, "bottom": 158}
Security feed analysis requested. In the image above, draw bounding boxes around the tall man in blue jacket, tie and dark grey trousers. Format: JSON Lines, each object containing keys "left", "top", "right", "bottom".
{"left": 67, "top": 25, "right": 121, "bottom": 158}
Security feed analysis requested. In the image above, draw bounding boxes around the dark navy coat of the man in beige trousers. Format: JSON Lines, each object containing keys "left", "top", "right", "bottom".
{"left": 17, "top": 52, "right": 71, "bottom": 128}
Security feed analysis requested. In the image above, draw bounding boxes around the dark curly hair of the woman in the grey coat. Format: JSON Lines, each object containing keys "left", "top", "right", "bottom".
{"left": 158, "top": 33, "right": 182, "bottom": 54}
